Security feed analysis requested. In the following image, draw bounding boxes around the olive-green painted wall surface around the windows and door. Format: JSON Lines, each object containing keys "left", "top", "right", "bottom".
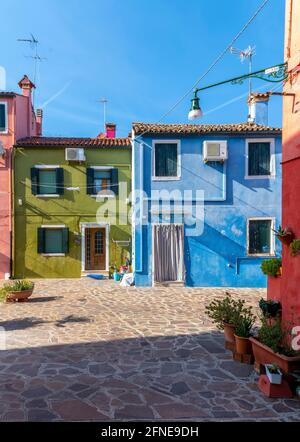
{"left": 13, "top": 147, "right": 131, "bottom": 278}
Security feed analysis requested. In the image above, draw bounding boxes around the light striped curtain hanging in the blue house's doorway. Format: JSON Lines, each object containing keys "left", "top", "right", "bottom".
{"left": 153, "top": 224, "right": 184, "bottom": 282}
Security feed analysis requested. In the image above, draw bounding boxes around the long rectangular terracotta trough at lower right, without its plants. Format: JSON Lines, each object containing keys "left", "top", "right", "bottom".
{"left": 250, "top": 338, "right": 300, "bottom": 374}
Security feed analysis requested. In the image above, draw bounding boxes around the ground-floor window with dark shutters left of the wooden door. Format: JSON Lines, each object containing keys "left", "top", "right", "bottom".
{"left": 38, "top": 226, "right": 69, "bottom": 256}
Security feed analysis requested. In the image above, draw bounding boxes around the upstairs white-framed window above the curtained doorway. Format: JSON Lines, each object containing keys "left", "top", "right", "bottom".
{"left": 153, "top": 141, "right": 180, "bottom": 179}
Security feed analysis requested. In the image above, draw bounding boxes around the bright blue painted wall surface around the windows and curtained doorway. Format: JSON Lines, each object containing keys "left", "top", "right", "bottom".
{"left": 133, "top": 133, "right": 281, "bottom": 287}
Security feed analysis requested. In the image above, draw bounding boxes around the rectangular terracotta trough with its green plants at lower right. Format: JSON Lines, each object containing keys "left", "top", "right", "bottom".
{"left": 250, "top": 317, "right": 300, "bottom": 374}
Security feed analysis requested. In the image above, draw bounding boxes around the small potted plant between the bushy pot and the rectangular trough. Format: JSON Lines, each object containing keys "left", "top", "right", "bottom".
{"left": 234, "top": 307, "right": 255, "bottom": 355}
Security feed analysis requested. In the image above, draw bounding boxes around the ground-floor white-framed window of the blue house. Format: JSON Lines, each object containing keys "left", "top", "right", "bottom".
{"left": 248, "top": 218, "right": 274, "bottom": 255}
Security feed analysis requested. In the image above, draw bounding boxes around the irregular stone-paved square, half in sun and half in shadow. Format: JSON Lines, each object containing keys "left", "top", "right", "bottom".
{"left": 0, "top": 278, "right": 300, "bottom": 421}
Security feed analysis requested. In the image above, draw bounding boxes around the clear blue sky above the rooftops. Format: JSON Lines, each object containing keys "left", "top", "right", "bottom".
{"left": 0, "top": 0, "right": 285, "bottom": 137}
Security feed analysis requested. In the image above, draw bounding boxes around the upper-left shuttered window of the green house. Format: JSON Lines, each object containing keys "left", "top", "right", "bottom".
{"left": 31, "top": 166, "right": 64, "bottom": 196}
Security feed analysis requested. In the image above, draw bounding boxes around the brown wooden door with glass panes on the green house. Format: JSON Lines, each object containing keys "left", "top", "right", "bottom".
{"left": 85, "top": 227, "right": 106, "bottom": 270}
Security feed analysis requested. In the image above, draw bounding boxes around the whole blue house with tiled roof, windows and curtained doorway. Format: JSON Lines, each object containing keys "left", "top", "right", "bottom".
{"left": 132, "top": 123, "right": 281, "bottom": 287}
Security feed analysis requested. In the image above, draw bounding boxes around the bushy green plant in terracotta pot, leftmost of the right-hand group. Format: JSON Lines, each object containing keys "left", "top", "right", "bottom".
{"left": 205, "top": 292, "right": 245, "bottom": 343}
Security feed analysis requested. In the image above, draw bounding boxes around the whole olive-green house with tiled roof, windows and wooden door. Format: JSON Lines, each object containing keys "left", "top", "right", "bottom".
{"left": 13, "top": 137, "right": 131, "bottom": 278}
